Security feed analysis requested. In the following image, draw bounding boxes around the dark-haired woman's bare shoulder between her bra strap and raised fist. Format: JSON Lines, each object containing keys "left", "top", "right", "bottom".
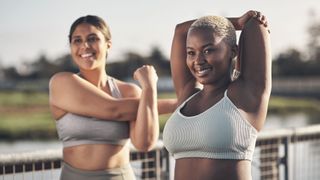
{"left": 113, "top": 78, "right": 141, "bottom": 98}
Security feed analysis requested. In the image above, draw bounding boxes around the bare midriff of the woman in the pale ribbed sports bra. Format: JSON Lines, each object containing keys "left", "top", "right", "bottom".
{"left": 174, "top": 158, "right": 252, "bottom": 180}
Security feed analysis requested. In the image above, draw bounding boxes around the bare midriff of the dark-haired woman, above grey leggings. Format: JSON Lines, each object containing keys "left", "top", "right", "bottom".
{"left": 63, "top": 144, "right": 129, "bottom": 171}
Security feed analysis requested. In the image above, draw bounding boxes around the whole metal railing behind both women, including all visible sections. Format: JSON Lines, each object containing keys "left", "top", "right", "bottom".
{"left": 0, "top": 125, "right": 320, "bottom": 180}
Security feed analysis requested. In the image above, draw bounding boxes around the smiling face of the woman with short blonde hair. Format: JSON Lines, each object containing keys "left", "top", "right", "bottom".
{"left": 187, "top": 28, "right": 235, "bottom": 85}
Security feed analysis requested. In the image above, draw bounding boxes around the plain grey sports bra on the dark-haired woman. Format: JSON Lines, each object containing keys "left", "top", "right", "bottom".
{"left": 56, "top": 77, "right": 129, "bottom": 147}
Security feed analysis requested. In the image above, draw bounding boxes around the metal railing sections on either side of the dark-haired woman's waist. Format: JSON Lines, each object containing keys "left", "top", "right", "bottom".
{"left": 0, "top": 141, "right": 169, "bottom": 180}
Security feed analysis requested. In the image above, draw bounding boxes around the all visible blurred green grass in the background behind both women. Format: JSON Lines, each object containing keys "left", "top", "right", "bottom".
{"left": 0, "top": 92, "right": 320, "bottom": 140}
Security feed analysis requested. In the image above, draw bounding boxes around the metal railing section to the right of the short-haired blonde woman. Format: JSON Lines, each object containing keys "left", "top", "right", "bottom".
{"left": 253, "top": 125, "right": 320, "bottom": 180}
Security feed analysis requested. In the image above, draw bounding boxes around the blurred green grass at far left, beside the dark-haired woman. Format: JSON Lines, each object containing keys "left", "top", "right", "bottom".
{"left": 0, "top": 92, "right": 57, "bottom": 140}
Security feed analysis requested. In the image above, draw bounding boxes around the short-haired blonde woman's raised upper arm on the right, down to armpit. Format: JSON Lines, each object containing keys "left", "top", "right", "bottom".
{"left": 229, "top": 19, "right": 271, "bottom": 130}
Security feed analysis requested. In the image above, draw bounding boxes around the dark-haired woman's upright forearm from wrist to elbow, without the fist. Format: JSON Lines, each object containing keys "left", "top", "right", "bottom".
{"left": 131, "top": 89, "right": 159, "bottom": 151}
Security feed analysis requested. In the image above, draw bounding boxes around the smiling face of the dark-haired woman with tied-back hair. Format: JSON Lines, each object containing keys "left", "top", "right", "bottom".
{"left": 70, "top": 23, "right": 111, "bottom": 70}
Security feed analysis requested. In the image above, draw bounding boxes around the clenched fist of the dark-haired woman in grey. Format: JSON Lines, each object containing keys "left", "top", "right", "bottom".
{"left": 133, "top": 65, "right": 158, "bottom": 89}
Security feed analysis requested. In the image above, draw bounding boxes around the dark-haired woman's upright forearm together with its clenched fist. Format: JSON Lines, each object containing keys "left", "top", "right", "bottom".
{"left": 130, "top": 65, "right": 159, "bottom": 151}
